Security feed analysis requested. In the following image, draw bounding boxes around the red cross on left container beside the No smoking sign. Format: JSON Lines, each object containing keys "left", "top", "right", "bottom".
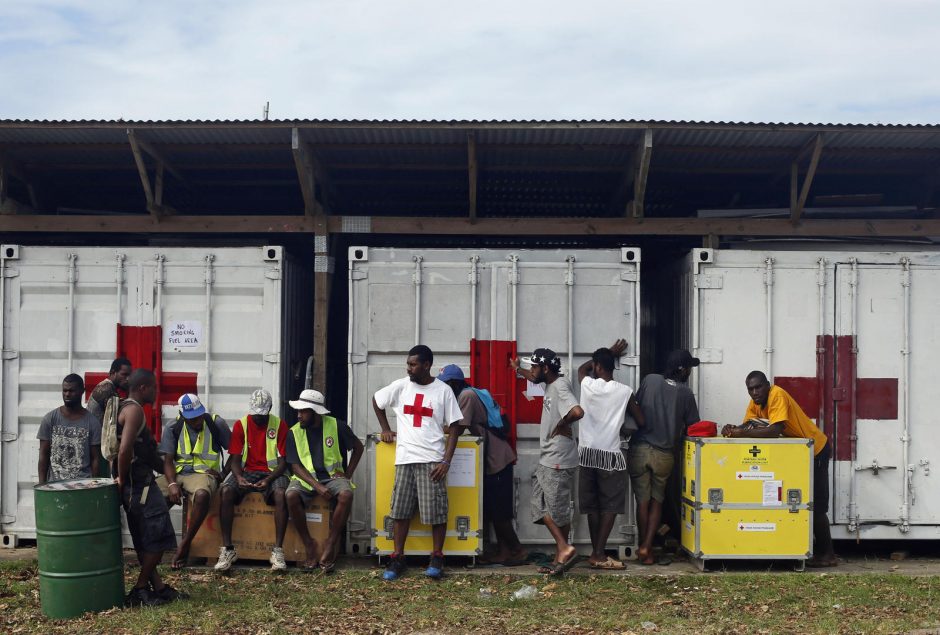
{"left": 85, "top": 324, "right": 196, "bottom": 439}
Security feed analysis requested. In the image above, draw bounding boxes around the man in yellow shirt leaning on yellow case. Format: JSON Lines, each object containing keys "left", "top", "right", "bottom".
{"left": 721, "top": 370, "right": 837, "bottom": 567}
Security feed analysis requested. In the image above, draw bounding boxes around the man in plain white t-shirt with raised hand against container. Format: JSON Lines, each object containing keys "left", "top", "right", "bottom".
{"left": 578, "top": 339, "right": 643, "bottom": 569}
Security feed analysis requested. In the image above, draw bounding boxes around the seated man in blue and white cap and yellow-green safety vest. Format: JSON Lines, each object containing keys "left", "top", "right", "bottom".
{"left": 156, "top": 393, "right": 232, "bottom": 569}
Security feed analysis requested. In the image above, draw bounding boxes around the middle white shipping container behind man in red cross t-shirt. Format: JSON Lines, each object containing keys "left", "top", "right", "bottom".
{"left": 348, "top": 247, "right": 640, "bottom": 551}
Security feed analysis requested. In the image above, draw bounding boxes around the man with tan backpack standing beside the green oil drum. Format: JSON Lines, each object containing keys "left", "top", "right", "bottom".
{"left": 111, "top": 368, "right": 188, "bottom": 606}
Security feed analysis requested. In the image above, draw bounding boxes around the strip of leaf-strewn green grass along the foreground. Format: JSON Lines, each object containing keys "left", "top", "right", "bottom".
{"left": 0, "top": 562, "right": 940, "bottom": 635}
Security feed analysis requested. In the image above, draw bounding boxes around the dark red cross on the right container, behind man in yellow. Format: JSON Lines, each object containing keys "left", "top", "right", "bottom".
{"left": 773, "top": 335, "right": 898, "bottom": 461}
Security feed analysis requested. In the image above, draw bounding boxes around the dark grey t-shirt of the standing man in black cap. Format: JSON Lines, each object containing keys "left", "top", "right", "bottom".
{"left": 630, "top": 374, "right": 699, "bottom": 452}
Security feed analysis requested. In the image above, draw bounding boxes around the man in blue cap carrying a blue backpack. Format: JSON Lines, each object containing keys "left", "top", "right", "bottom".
{"left": 437, "top": 364, "right": 528, "bottom": 567}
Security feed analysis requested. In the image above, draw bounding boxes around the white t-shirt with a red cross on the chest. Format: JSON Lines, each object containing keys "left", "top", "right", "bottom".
{"left": 375, "top": 377, "right": 463, "bottom": 465}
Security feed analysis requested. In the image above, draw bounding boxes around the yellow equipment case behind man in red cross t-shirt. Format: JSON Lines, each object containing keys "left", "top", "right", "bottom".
{"left": 368, "top": 434, "right": 483, "bottom": 558}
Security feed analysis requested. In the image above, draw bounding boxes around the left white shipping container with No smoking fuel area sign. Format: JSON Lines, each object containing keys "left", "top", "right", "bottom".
{"left": 0, "top": 245, "right": 309, "bottom": 546}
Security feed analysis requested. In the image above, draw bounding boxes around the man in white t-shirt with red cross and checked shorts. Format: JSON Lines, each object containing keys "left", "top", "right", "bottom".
{"left": 372, "top": 344, "right": 463, "bottom": 580}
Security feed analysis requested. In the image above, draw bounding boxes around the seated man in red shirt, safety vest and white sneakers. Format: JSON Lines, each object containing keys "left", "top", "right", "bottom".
{"left": 215, "top": 389, "right": 287, "bottom": 572}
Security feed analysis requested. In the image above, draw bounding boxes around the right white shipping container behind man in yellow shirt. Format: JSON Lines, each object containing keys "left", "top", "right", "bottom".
{"left": 679, "top": 249, "right": 940, "bottom": 539}
